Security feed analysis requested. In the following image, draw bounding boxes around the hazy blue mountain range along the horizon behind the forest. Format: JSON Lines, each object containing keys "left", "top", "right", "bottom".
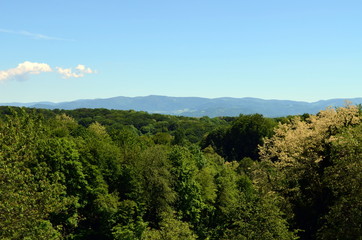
{"left": 0, "top": 95, "right": 362, "bottom": 117}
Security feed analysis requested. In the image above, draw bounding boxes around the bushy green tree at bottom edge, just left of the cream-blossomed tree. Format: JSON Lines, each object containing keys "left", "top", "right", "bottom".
{"left": 214, "top": 162, "right": 297, "bottom": 240}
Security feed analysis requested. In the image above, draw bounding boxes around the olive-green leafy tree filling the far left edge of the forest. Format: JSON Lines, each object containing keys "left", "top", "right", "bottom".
{"left": 0, "top": 109, "right": 66, "bottom": 239}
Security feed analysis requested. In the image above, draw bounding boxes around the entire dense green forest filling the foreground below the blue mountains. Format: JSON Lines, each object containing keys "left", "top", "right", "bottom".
{"left": 0, "top": 105, "right": 362, "bottom": 240}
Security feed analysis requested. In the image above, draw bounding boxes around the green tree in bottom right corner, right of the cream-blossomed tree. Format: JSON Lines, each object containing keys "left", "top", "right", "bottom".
{"left": 317, "top": 125, "right": 362, "bottom": 240}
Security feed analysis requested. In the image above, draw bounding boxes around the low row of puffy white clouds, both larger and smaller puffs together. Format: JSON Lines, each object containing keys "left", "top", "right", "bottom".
{"left": 0, "top": 61, "right": 95, "bottom": 82}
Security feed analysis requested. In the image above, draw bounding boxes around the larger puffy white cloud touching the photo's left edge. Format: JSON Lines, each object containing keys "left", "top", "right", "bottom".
{"left": 0, "top": 61, "right": 52, "bottom": 81}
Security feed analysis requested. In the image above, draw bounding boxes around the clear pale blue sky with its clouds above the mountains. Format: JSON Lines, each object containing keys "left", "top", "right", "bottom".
{"left": 0, "top": 0, "right": 362, "bottom": 103}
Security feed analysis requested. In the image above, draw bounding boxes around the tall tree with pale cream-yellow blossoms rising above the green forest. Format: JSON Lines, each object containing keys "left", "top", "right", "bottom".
{"left": 255, "top": 106, "right": 361, "bottom": 239}
